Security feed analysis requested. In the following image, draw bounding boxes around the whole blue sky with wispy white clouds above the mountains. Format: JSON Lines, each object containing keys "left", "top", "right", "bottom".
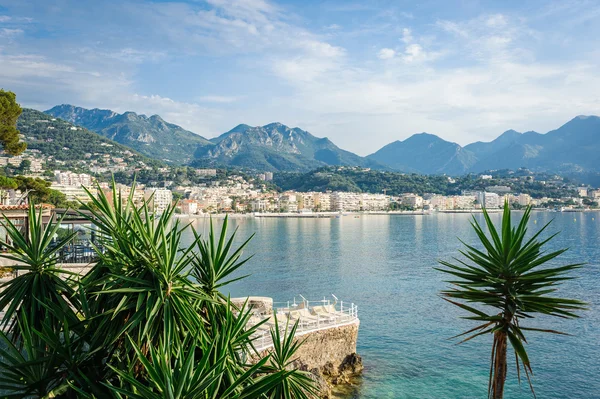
{"left": 0, "top": 0, "right": 600, "bottom": 155}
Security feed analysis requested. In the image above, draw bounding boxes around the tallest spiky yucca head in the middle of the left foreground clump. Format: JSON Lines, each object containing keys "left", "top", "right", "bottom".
{"left": 82, "top": 183, "right": 206, "bottom": 363}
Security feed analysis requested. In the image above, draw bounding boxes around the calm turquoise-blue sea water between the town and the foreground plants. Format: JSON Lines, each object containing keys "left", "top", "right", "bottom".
{"left": 185, "top": 212, "right": 600, "bottom": 399}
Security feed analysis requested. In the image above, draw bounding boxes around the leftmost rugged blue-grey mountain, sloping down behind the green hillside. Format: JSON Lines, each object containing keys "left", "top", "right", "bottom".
{"left": 45, "top": 104, "right": 212, "bottom": 164}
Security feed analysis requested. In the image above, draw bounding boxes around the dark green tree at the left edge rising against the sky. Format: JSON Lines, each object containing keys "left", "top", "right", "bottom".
{"left": 0, "top": 89, "right": 27, "bottom": 155}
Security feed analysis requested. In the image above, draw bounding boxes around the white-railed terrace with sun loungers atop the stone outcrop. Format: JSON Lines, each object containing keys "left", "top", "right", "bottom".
{"left": 250, "top": 296, "right": 358, "bottom": 351}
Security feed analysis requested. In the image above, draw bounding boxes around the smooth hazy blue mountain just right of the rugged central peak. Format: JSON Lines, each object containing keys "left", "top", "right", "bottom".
{"left": 368, "top": 133, "right": 477, "bottom": 175}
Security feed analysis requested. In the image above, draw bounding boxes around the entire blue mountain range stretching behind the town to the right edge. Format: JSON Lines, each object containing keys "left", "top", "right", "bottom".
{"left": 46, "top": 105, "right": 600, "bottom": 175}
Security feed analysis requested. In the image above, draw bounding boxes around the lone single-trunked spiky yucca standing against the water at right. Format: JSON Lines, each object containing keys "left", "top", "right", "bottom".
{"left": 437, "top": 202, "right": 585, "bottom": 399}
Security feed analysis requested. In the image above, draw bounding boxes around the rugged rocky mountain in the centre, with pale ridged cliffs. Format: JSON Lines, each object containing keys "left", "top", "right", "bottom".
{"left": 195, "top": 123, "right": 385, "bottom": 171}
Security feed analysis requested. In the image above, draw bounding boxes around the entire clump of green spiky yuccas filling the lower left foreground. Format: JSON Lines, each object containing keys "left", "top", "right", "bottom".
{"left": 0, "top": 188, "right": 314, "bottom": 399}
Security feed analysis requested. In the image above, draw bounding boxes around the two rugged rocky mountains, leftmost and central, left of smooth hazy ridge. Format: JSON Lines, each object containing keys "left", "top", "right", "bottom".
{"left": 45, "top": 104, "right": 387, "bottom": 172}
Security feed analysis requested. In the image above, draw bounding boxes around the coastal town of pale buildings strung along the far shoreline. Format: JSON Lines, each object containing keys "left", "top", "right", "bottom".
{"left": 0, "top": 165, "right": 600, "bottom": 215}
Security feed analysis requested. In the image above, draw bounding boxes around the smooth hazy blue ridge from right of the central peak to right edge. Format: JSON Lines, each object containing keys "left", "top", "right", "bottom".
{"left": 368, "top": 116, "right": 600, "bottom": 175}
